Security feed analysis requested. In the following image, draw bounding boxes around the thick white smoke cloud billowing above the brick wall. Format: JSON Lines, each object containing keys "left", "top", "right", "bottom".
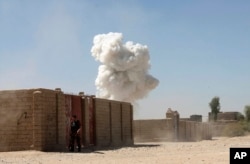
{"left": 91, "top": 33, "right": 159, "bottom": 102}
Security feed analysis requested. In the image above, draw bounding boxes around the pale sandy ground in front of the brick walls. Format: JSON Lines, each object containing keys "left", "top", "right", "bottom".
{"left": 0, "top": 135, "right": 250, "bottom": 164}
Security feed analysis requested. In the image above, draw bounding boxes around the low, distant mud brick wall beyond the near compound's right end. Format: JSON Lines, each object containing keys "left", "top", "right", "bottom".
{"left": 134, "top": 109, "right": 212, "bottom": 142}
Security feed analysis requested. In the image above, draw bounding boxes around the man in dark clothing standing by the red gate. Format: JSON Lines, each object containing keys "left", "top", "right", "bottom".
{"left": 69, "top": 115, "right": 81, "bottom": 152}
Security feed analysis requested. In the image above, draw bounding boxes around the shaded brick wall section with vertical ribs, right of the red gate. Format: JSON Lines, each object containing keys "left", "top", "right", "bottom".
{"left": 95, "top": 98, "right": 133, "bottom": 147}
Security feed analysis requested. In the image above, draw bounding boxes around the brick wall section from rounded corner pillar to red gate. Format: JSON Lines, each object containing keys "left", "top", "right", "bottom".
{"left": 32, "top": 89, "right": 66, "bottom": 151}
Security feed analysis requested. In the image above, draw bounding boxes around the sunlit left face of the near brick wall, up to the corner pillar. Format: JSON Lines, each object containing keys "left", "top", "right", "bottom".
{"left": 0, "top": 91, "right": 33, "bottom": 151}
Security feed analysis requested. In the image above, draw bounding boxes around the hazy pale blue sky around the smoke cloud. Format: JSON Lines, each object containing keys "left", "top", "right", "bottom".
{"left": 0, "top": 0, "right": 250, "bottom": 119}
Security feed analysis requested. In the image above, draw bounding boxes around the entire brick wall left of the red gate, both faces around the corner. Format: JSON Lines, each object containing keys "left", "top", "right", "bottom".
{"left": 0, "top": 89, "right": 65, "bottom": 151}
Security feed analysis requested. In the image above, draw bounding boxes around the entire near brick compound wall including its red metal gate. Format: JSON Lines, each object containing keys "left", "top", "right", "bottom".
{"left": 0, "top": 88, "right": 134, "bottom": 151}
